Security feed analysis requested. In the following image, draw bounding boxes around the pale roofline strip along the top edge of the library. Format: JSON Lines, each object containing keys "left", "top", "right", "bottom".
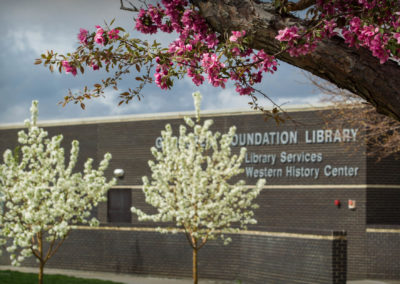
{"left": 0, "top": 104, "right": 332, "bottom": 130}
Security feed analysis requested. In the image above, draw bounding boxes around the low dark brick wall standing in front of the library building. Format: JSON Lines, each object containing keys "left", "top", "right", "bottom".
{"left": 0, "top": 229, "right": 346, "bottom": 284}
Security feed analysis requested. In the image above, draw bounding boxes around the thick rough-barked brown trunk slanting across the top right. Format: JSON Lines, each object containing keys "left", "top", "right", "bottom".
{"left": 192, "top": 0, "right": 400, "bottom": 121}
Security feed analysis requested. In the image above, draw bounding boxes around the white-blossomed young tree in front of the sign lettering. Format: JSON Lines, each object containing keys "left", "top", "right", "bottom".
{"left": 132, "top": 92, "right": 265, "bottom": 284}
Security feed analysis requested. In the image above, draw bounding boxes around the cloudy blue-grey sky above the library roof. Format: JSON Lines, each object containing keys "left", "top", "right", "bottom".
{"left": 0, "top": 0, "right": 318, "bottom": 124}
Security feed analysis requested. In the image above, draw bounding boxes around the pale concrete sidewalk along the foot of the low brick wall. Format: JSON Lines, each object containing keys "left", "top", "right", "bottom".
{"left": 0, "top": 265, "right": 400, "bottom": 284}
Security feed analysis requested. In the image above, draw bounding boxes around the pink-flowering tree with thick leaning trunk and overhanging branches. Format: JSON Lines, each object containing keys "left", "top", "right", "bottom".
{"left": 36, "top": 0, "right": 400, "bottom": 120}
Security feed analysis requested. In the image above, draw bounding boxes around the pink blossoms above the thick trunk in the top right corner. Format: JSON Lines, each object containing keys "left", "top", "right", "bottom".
{"left": 276, "top": 0, "right": 400, "bottom": 63}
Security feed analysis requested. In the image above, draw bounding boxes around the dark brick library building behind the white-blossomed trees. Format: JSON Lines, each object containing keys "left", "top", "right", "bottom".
{"left": 0, "top": 107, "right": 400, "bottom": 284}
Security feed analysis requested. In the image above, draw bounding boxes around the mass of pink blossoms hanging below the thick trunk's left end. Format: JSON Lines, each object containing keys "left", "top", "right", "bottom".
{"left": 136, "top": 0, "right": 277, "bottom": 95}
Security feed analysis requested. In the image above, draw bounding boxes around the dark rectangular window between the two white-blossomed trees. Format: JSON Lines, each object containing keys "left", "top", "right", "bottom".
{"left": 107, "top": 188, "right": 132, "bottom": 223}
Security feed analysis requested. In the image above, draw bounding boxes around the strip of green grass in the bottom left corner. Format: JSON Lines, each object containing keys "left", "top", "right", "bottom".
{"left": 0, "top": 270, "right": 121, "bottom": 284}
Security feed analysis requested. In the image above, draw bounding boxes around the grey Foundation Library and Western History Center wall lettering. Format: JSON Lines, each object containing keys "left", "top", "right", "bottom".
{"left": 155, "top": 128, "right": 360, "bottom": 180}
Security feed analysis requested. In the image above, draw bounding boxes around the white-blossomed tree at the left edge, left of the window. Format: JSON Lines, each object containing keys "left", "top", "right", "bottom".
{"left": 0, "top": 101, "right": 115, "bottom": 284}
